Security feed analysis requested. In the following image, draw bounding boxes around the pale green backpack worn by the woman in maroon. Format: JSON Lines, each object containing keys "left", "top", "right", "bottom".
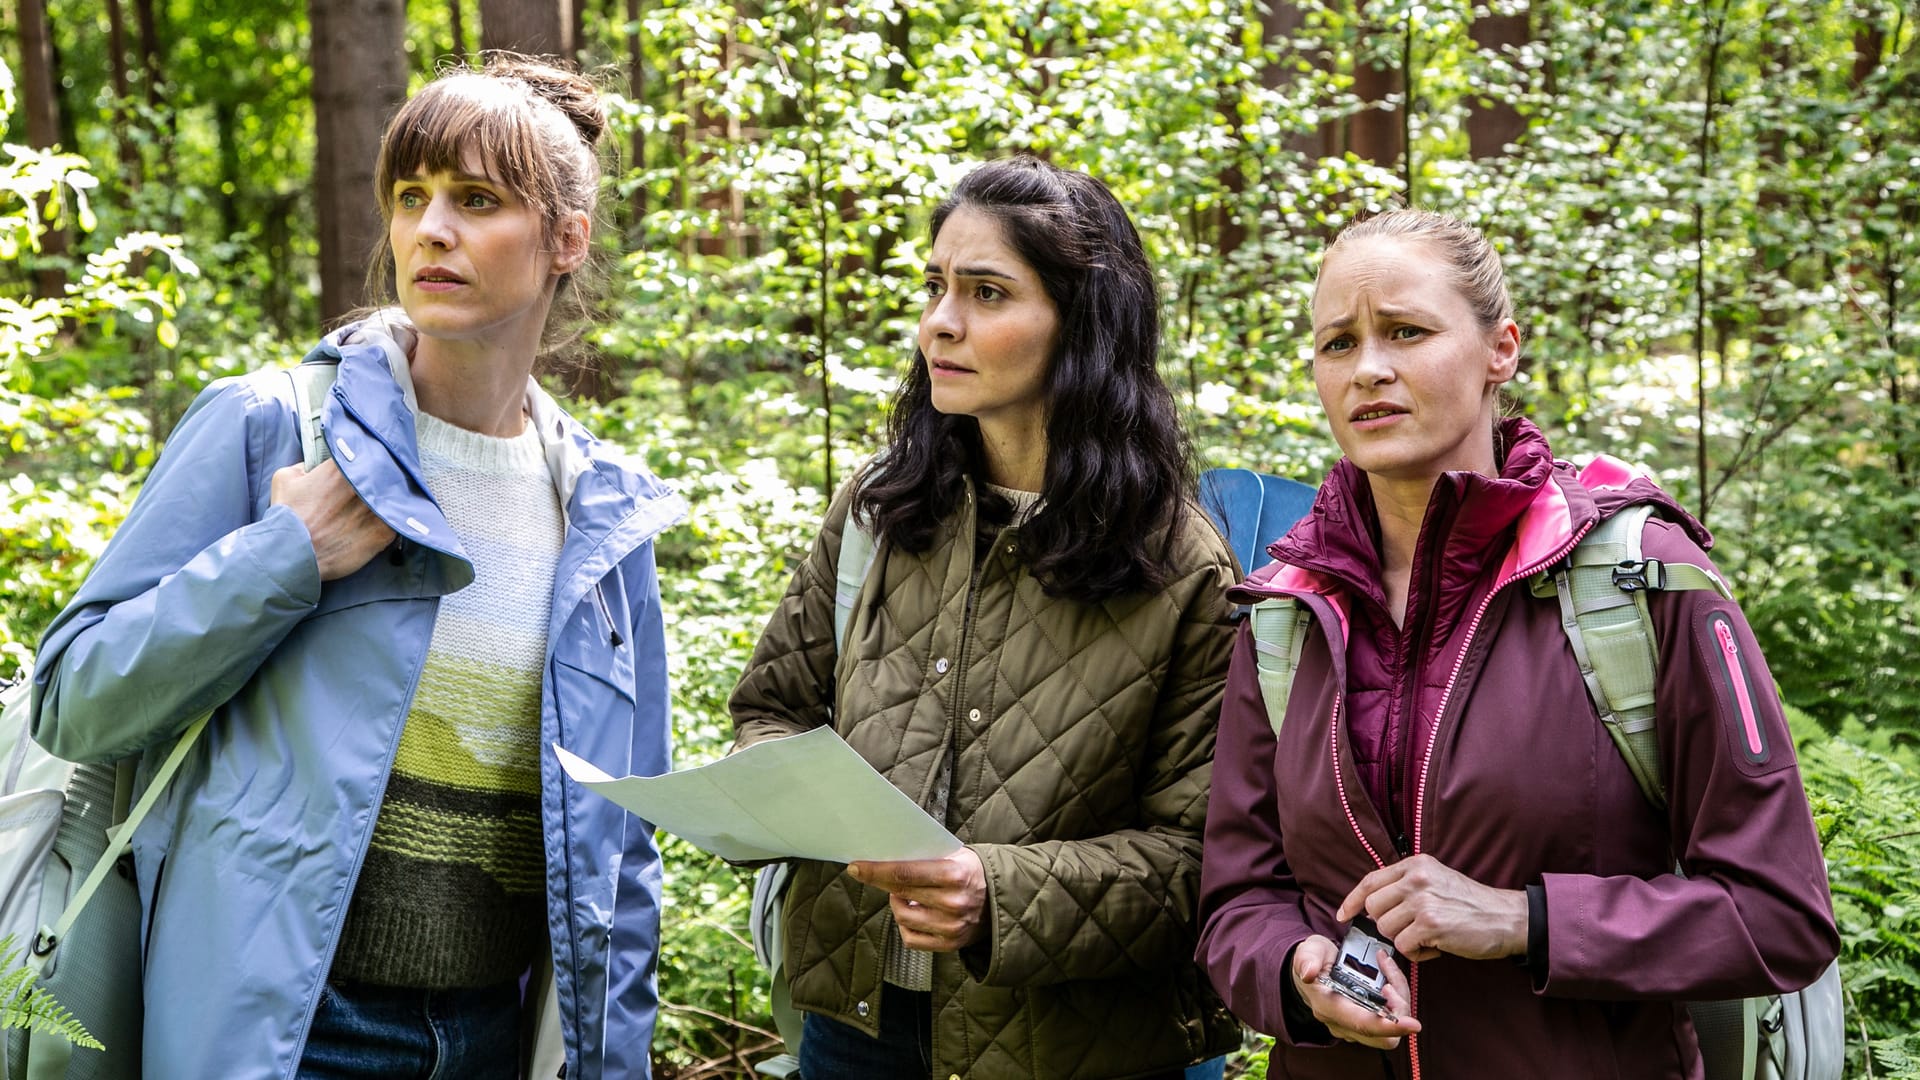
{"left": 1227, "top": 472, "right": 1845, "bottom": 1080}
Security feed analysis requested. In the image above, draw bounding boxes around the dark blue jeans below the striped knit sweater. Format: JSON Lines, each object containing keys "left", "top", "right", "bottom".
{"left": 298, "top": 980, "right": 520, "bottom": 1080}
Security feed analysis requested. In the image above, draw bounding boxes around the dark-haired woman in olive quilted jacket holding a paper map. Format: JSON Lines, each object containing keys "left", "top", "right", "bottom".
{"left": 732, "top": 158, "right": 1238, "bottom": 1080}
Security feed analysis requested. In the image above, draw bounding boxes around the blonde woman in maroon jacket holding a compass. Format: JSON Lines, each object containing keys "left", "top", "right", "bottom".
{"left": 1198, "top": 209, "right": 1839, "bottom": 1078}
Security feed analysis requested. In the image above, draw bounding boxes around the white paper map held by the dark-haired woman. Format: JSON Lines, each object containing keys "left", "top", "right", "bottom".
{"left": 553, "top": 726, "right": 960, "bottom": 863}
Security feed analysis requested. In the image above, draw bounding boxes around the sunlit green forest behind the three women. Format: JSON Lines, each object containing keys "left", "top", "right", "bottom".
{"left": 0, "top": 0, "right": 1920, "bottom": 1078}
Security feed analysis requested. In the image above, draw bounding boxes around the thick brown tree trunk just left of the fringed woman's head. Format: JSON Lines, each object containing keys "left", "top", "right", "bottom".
{"left": 307, "top": 0, "right": 407, "bottom": 321}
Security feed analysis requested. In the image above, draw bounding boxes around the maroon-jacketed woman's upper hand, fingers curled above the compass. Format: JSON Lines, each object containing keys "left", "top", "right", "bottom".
{"left": 1334, "top": 855, "right": 1526, "bottom": 961}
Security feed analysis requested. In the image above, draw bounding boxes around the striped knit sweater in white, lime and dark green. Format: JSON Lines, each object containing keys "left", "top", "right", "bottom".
{"left": 332, "top": 405, "right": 566, "bottom": 988}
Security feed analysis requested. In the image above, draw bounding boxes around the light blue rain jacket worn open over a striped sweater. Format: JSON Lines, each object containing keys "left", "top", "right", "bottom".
{"left": 35, "top": 317, "right": 685, "bottom": 1080}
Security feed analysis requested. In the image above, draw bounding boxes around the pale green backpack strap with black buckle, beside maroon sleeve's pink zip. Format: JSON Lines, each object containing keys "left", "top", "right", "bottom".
{"left": 1532, "top": 503, "right": 1730, "bottom": 809}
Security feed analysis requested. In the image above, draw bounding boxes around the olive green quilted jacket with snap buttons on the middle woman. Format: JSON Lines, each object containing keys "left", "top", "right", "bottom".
{"left": 730, "top": 480, "right": 1240, "bottom": 1080}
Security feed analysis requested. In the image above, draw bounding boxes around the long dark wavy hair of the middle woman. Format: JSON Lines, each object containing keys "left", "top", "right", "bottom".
{"left": 854, "top": 158, "right": 1192, "bottom": 603}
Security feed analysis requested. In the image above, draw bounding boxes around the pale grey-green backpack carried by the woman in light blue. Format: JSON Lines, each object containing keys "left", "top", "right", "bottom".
{"left": 0, "top": 361, "right": 338, "bottom": 1080}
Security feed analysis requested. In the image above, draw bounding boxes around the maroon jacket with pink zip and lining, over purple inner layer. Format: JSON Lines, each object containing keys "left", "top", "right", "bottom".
{"left": 1198, "top": 421, "right": 1839, "bottom": 1080}
